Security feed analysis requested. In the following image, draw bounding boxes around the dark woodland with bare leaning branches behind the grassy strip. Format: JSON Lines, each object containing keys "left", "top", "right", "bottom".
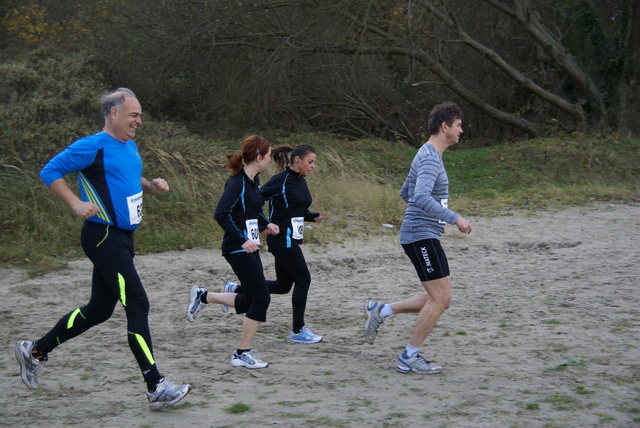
{"left": 0, "top": 0, "right": 640, "bottom": 148}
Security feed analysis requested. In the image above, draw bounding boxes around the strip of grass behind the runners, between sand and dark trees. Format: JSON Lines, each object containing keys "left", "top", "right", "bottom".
{"left": 0, "top": 128, "right": 640, "bottom": 270}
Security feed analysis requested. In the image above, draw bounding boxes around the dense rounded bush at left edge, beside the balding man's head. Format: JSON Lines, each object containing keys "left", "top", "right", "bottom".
{"left": 0, "top": 48, "right": 106, "bottom": 164}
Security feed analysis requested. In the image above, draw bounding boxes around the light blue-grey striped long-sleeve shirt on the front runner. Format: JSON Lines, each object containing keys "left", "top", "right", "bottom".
{"left": 400, "top": 143, "right": 460, "bottom": 244}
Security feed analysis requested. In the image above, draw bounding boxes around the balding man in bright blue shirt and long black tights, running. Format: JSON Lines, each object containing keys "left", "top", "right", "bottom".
{"left": 15, "top": 88, "right": 191, "bottom": 409}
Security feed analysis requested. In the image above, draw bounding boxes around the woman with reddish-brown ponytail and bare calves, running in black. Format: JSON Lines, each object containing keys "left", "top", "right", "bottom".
{"left": 187, "top": 135, "right": 279, "bottom": 369}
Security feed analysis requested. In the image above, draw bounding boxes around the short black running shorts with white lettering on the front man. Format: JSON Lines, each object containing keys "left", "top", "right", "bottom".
{"left": 402, "top": 239, "right": 450, "bottom": 282}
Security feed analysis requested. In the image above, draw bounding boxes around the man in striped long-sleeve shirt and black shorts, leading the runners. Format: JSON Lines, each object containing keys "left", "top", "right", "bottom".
{"left": 364, "top": 102, "right": 471, "bottom": 374}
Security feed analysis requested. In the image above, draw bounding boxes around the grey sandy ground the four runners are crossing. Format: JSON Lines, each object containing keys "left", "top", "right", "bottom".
{"left": 0, "top": 203, "right": 640, "bottom": 427}
